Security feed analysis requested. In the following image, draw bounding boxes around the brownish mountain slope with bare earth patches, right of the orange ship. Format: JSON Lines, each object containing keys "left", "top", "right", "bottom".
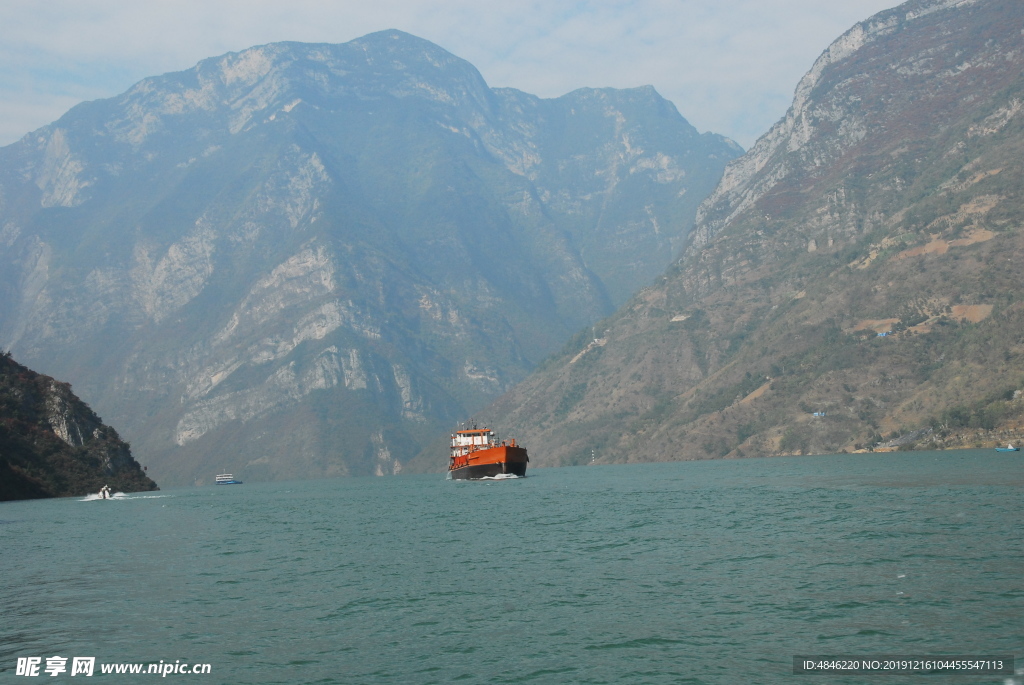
{"left": 479, "top": 0, "right": 1024, "bottom": 465}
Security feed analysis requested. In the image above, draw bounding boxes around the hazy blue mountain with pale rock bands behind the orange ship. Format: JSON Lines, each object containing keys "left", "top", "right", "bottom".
{"left": 0, "top": 31, "right": 742, "bottom": 484}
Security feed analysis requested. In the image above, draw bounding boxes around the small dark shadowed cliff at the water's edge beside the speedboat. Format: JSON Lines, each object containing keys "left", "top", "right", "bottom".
{"left": 0, "top": 354, "right": 157, "bottom": 501}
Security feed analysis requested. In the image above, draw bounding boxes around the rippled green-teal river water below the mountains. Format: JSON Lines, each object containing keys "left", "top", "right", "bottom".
{"left": 0, "top": 449, "right": 1024, "bottom": 685}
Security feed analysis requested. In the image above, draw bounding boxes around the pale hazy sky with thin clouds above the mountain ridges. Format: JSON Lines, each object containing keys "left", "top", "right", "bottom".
{"left": 0, "top": 0, "right": 898, "bottom": 147}
